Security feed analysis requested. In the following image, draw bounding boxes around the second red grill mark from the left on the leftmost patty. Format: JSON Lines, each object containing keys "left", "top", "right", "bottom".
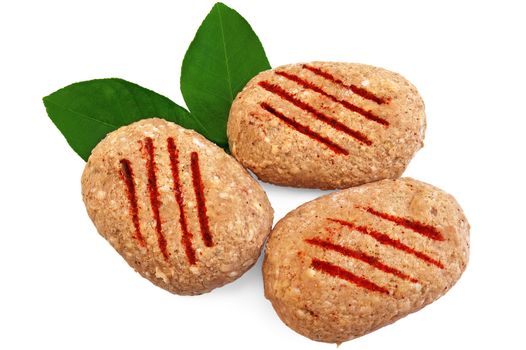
{"left": 144, "top": 137, "right": 170, "bottom": 260}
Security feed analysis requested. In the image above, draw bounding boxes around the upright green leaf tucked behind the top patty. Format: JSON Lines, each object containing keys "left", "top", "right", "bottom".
{"left": 181, "top": 3, "right": 270, "bottom": 146}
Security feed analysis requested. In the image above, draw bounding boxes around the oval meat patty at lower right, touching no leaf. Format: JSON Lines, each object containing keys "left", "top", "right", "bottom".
{"left": 263, "top": 178, "right": 469, "bottom": 343}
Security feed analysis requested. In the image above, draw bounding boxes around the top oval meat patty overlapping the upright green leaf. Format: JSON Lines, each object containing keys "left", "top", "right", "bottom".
{"left": 227, "top": 62, "right": 425, "bottom": 189}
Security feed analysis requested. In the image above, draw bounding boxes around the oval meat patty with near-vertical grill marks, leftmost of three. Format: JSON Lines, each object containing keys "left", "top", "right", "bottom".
{"left": 82, "top": 119, "right": 273, "bottom": 294}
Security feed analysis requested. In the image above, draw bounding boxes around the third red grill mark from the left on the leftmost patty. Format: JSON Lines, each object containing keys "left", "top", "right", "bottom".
{"left": 167, "top": 137, "right": 196, "bottom": 265}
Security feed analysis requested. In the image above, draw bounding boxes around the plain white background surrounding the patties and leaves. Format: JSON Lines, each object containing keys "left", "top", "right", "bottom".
{"left": 0, "top": 0, "right": 526, "bottom": 350}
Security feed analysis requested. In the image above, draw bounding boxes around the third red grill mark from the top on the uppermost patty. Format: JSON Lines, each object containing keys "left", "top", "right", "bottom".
{"left": 258, "top": 81, "right": 372, "bottom": 146}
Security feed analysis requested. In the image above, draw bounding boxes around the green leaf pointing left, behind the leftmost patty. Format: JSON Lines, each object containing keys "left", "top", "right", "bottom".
{"left": 43, "top": 78, "right": 202, "bottom": 160}
